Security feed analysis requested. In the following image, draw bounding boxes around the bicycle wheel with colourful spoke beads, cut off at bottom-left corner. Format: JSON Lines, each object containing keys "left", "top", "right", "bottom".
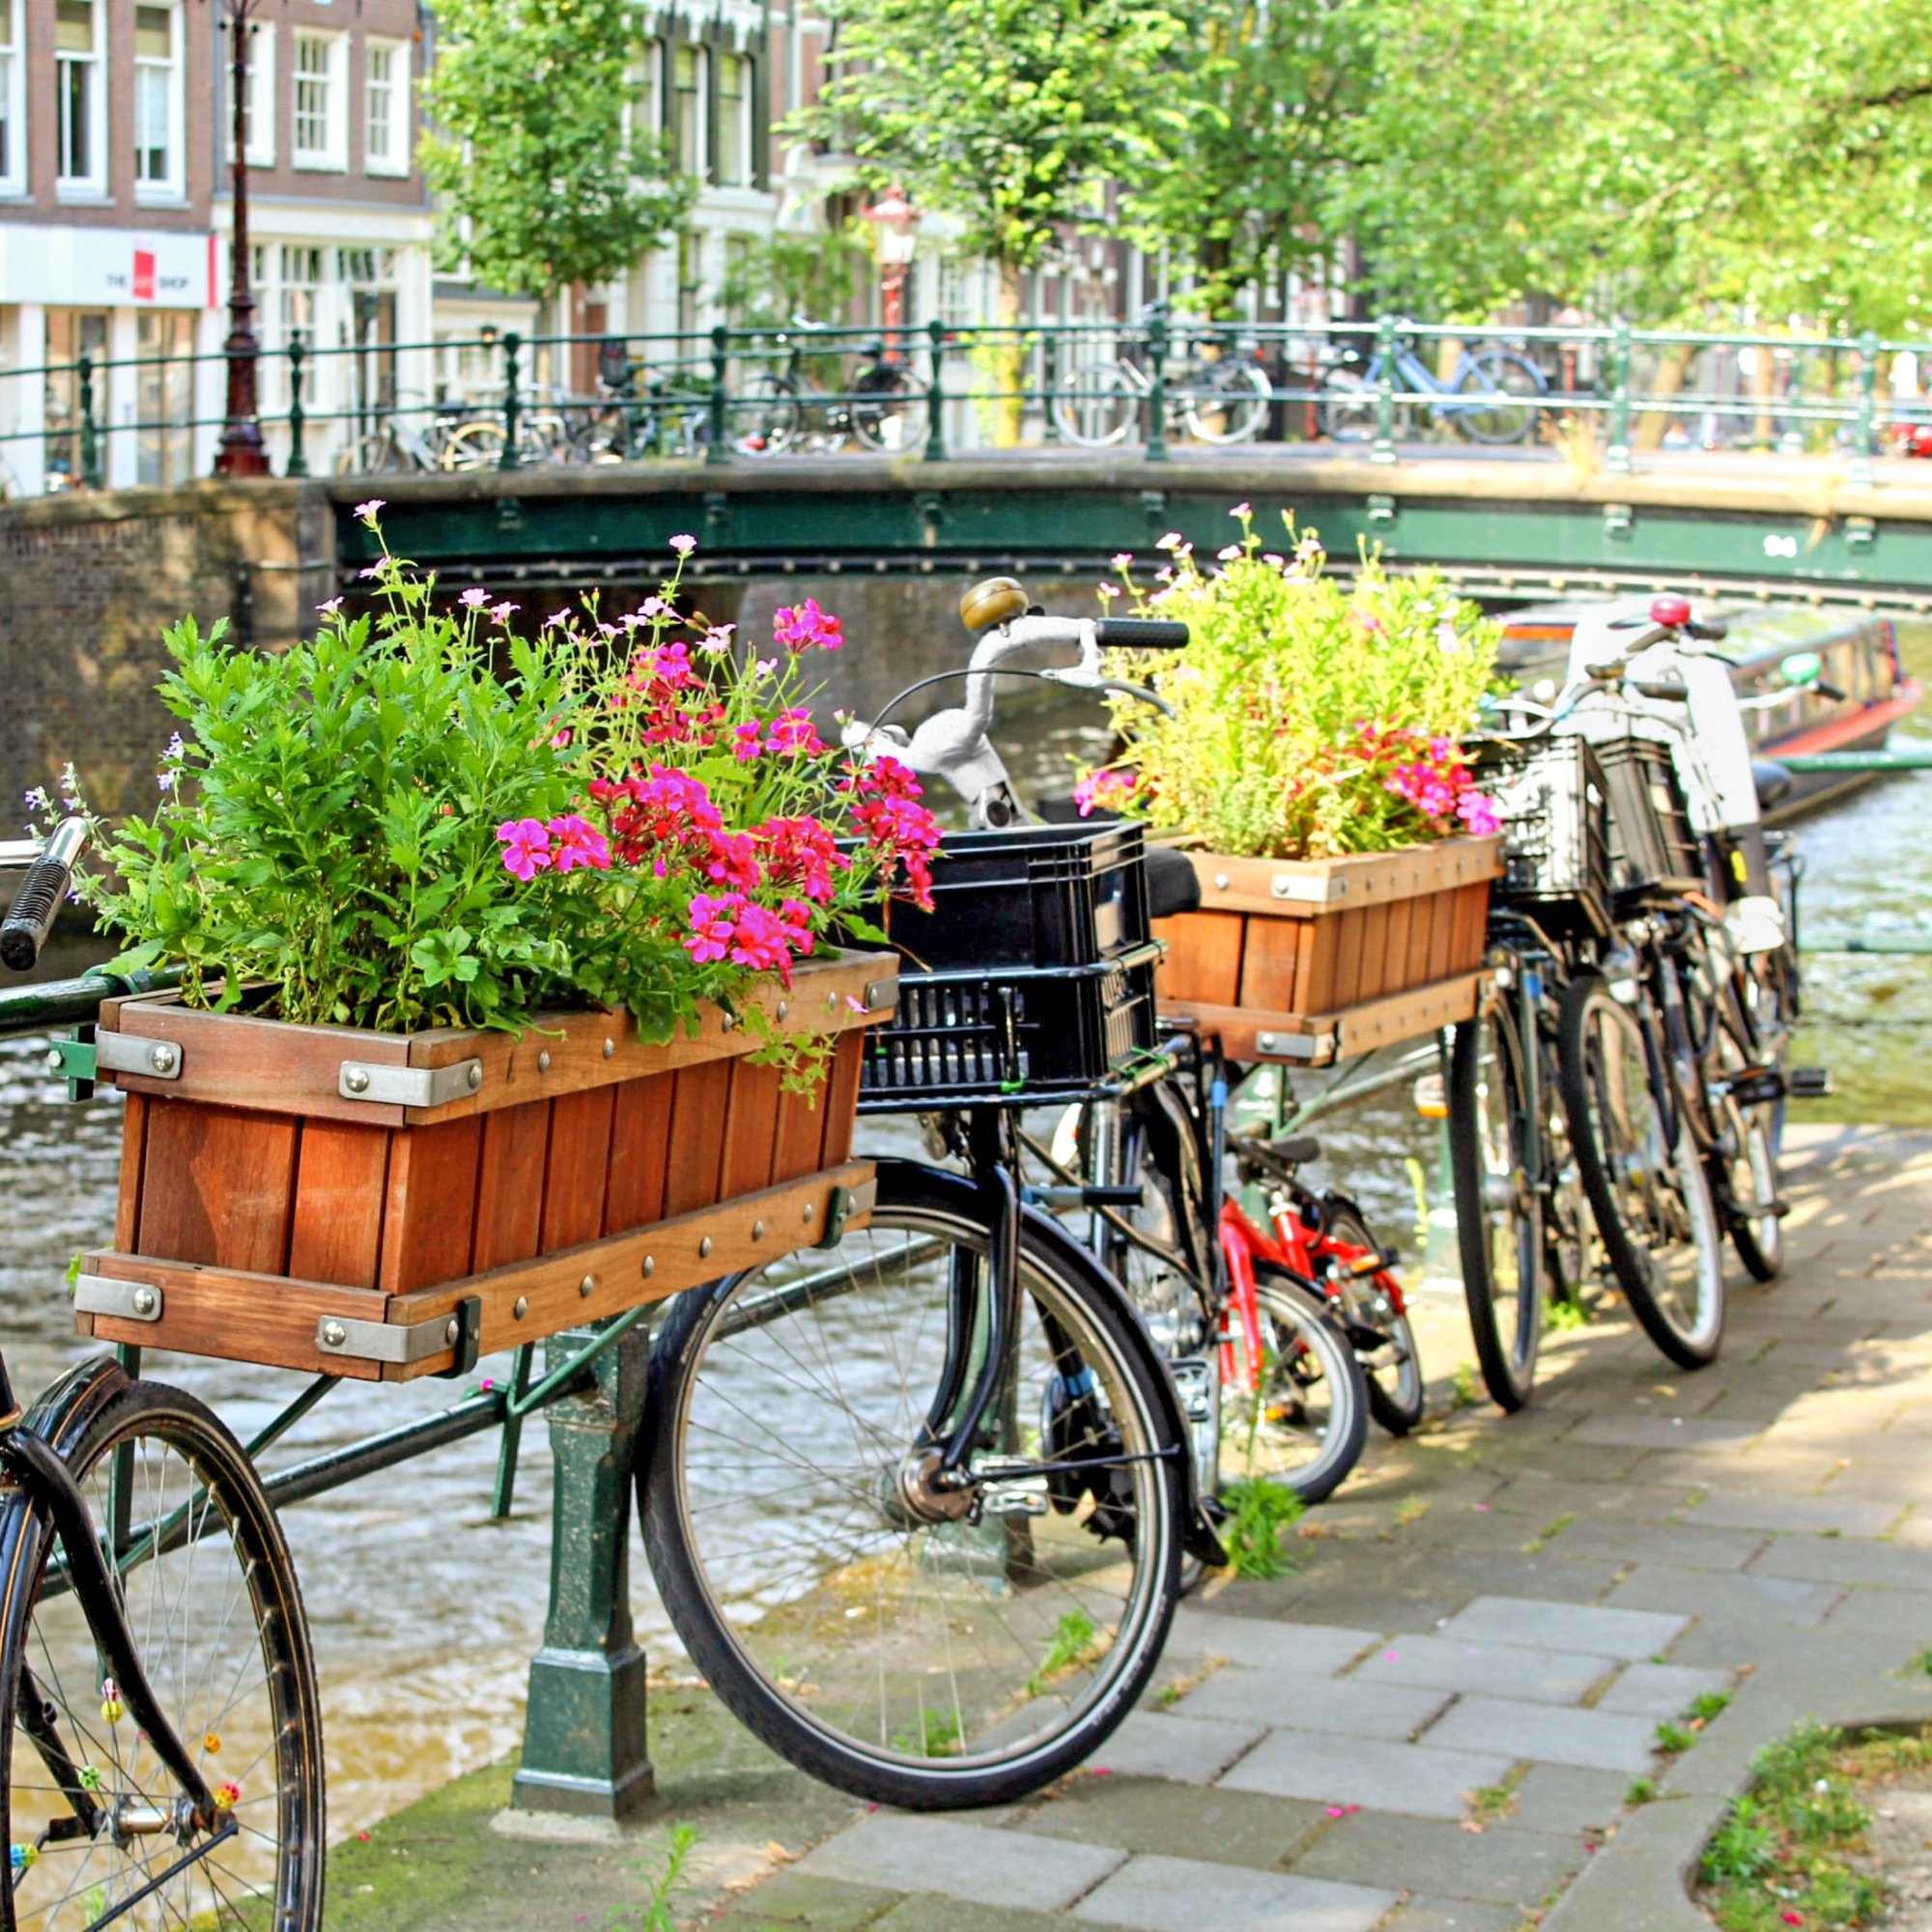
{"left": 0, "top": 1364, "right": 325, "bottom": 1932}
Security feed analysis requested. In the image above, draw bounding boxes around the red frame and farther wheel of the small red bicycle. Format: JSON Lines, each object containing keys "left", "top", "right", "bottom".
{"left": 1221, "top": 1134, "right": 1424, "bottom": 1435}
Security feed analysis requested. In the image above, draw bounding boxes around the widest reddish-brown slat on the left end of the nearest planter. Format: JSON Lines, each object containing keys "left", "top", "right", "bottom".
{"left": 137, "top": 1099, "right": 296, "bottom": 1275}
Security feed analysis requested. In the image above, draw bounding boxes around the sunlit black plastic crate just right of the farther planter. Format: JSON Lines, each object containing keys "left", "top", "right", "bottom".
{"left": 1476, "top": 736, "right": 1611, "bottom": 931}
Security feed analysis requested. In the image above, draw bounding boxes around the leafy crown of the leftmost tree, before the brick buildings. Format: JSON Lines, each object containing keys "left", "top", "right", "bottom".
{"left": 423, "top": 0, "right": 694, "bottom": 325}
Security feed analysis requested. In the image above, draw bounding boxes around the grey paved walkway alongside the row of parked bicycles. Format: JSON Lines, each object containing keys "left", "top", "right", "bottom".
{"left": 719, "top": 1128, "right": 1932, "bottom": 1932}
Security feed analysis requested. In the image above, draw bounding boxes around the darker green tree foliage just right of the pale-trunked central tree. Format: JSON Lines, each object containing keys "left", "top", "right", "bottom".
{"left": 1124, "top": 0, "right": 1374, "bottom": 315}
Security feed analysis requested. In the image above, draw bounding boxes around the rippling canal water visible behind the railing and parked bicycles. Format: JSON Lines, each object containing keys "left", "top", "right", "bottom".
{"left": 0, "top": 611, "right": 1932, "bottom": 1835}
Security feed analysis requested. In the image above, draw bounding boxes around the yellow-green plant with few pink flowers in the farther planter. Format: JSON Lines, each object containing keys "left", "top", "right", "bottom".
{"left": 1076, "top": 504, "right": 1501, "bottom": 860}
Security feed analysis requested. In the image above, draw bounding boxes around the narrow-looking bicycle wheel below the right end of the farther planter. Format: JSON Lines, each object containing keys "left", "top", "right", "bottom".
{"left": 1449, "top": 987, "right": 1546, "bottom": 1412}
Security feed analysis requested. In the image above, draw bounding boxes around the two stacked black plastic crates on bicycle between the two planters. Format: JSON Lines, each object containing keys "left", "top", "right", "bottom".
{"left": 860, "top": 823, "right": 1159, "bottom": 1113}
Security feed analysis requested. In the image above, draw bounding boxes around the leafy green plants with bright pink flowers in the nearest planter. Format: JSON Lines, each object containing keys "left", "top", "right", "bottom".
{"left": 43, "top": 502, "right": 939, "bottom": 1057}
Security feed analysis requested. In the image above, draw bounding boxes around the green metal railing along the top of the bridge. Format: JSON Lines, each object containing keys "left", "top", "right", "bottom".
{"left": 0, "top": 315, "right": 1932, "bottom": 495}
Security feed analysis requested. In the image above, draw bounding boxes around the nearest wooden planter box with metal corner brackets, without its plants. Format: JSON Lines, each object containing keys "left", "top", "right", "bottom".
{"left": 75, "top": 954, "right": 898, "bottom": 1381}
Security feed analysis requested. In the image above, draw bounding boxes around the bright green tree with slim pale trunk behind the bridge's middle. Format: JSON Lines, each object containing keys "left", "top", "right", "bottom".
{"left": 796, "top": 0, "right": 1179, "bottom": 440}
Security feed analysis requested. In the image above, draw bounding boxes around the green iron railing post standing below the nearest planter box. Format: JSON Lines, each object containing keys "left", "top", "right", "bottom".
{"left": 510, "top": 1321, "right": 655, "bottom": 1818}
